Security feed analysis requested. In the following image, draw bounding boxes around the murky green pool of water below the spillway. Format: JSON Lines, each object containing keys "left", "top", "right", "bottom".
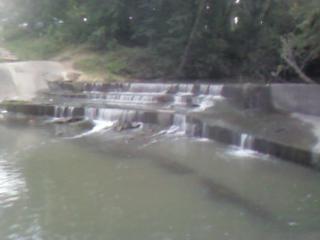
{"left": 0, "top": 125, "right": 320, "bottom": 240}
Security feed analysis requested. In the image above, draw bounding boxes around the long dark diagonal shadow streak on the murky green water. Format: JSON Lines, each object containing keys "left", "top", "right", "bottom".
{"left": 74, "top": 135, "right": 287, "bottom": 229}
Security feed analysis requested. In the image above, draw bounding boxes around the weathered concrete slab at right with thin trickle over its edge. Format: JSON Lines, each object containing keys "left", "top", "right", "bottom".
{"left": 188, "top": 102, "right": 320, "bottom": 166}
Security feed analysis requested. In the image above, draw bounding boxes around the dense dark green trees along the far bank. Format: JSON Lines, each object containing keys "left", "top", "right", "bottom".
{"left": 0, "top": 0, "right": 320, "bottom": 79}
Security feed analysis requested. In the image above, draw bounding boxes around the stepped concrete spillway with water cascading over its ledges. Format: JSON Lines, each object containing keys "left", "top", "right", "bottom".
{"left": 1, "top": 82, "right": 320, "bottom": 169}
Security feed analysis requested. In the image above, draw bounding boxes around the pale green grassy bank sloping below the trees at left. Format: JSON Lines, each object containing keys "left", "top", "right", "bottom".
{"left": 2, "top": 30, "right": 172, "bottom": 81}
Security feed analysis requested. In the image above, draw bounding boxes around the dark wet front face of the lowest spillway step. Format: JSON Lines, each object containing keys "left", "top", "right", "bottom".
{"left": 0, "top": 103, "right": 319, "bottom": 168}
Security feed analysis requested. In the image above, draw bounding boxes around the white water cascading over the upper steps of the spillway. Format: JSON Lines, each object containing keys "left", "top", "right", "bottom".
{"left": 75, "top": 83, "right": 228, "bottom": 110}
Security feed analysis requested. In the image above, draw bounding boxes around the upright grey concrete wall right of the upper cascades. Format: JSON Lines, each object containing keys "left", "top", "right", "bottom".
{"left": 223, "top": 84, "right": 320, "bottom": 117}
